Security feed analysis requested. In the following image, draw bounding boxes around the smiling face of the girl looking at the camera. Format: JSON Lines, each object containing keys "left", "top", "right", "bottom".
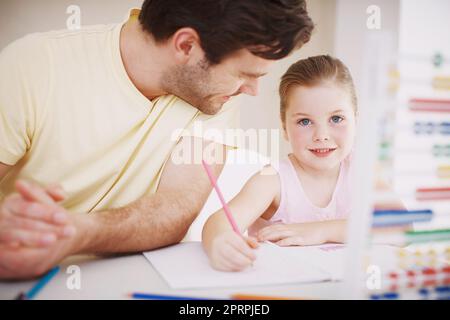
{"left": 284, "top": 83, "right": 356, "bottom": 171}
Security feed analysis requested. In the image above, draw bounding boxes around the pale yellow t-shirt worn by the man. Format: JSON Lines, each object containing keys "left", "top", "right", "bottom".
{"left": 0, "top": 16, "right": 238, "bottom": 212}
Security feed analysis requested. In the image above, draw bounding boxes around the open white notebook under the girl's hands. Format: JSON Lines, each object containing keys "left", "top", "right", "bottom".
{"left": 144, "top": 242, "right": 346, "bottom": 289}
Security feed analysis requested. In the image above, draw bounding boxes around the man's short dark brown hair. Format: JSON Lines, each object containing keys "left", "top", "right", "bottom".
{"left": 139, "top": 0, "right": 314, "bottom": 64}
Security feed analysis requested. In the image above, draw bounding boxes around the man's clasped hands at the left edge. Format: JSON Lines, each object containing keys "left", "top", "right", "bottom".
{"left": 0, "top": 181, "right": 83, "bottom": 279}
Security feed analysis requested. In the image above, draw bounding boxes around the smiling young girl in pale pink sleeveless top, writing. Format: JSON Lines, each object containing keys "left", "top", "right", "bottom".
{"left": 202, "top": 56, "right": 357, "bottom": 271}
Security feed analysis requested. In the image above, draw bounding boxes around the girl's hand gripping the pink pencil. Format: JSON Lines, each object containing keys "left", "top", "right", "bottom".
{"left": 208, "top": 231, "right": 259, "bottom": 271}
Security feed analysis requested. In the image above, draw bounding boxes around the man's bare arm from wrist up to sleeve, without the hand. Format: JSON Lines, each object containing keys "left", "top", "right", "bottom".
{"left": 75, "top": 137, "right": 226, "bottom": 253}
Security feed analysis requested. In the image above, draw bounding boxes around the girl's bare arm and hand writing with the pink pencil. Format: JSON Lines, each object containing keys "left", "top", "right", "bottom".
{"left": 202, "top": 167, "right": 280, "bottom": 271}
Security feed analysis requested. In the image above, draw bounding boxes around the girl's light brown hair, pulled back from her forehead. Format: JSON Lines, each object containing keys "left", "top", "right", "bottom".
{"left": 279, "top": 55, "right": 357, "bottom": 127}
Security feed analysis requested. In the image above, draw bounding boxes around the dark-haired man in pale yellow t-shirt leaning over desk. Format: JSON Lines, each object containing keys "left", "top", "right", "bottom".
{"left": 0, "top": 0, "right": 313, "bottom": 278}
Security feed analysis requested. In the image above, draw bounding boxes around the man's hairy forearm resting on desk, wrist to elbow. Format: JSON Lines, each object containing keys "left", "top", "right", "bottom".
{"left": 75, "top": 193, "right": 202, "bottom": 253}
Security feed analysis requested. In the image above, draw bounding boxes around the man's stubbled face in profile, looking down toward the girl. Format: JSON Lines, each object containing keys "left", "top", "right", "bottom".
{"left": 161, "top": 49, "right": 273, "bottom": 114}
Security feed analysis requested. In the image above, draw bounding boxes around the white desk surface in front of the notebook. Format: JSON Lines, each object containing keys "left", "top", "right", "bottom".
{"left": 0, "top": 249, "right": 342, "bottom": 300}
